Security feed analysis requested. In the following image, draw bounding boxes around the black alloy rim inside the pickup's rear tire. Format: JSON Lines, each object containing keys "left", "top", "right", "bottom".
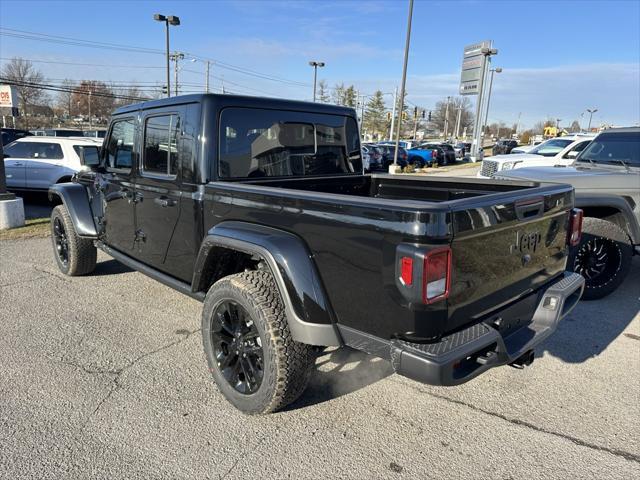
{"left": 211, "top": 300, "right": 264, "bottom": 394}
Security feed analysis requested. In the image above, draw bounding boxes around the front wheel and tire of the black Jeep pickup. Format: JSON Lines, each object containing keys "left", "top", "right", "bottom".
{"left": 51, "top": 205, "right": 98, "bottom": 276}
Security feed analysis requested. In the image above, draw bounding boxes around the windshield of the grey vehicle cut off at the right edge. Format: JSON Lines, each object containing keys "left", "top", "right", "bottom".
{"left": 577, "top": 132, "right": 640, "bottom": 167}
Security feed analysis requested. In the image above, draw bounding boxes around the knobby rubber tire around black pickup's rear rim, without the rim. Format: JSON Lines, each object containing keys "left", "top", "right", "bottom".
{"left": 202, "top": 271, "right": 315, "bottom": 415}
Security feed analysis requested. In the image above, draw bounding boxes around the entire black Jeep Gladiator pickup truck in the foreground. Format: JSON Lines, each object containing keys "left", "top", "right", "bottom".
{"left": 49, "top": 94, "right": 584, "bottom": 413}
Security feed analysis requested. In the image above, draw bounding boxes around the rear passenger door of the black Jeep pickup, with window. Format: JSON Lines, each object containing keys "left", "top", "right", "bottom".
{"left": 134, "top": 110, "right": 183, "bottom": 274}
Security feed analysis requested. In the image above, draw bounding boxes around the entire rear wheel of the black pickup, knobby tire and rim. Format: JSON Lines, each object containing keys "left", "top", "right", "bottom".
{"left": 202, "top": 271, "right": 314, "bottom": 414}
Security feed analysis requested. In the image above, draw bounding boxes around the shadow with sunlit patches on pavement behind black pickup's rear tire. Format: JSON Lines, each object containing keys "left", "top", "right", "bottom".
{"left": 285, "top": 347, "right": 394, "bottom": 410}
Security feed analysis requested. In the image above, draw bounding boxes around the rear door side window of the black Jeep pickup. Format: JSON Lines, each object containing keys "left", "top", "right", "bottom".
{"left": 142, "top": 115, "right": 180, "bottom": 176}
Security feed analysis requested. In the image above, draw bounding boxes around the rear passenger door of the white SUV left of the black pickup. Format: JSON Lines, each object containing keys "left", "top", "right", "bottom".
{"left": 25, "top": 142, "right": 65, "bottom": 190}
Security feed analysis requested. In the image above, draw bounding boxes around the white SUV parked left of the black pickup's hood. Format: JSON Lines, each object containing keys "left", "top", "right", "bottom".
{"left": 4, "top": 136, "right": 102, "bottom": 191}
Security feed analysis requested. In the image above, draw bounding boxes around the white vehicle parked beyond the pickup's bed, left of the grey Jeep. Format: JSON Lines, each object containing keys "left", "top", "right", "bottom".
{"left": 478, "top": 135, "right": 595, "bottom": 178}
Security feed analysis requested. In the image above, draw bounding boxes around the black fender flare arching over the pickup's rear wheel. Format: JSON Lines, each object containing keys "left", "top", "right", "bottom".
{"left": 192, "top": 221, "right": 343, "bottom": 346}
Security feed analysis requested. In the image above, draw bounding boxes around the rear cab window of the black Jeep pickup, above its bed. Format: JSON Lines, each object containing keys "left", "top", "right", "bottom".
{"left": 218, "top": 108, "right": 362, "bottom": 178}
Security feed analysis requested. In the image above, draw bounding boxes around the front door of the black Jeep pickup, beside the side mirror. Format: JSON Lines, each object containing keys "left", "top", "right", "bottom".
{"left": 99, "top": 118, "right": 136, "bottom": 254}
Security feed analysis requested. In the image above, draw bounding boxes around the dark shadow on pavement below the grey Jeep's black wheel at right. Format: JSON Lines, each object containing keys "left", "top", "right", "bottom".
{"left": 541, "top": 257, "right": 640, "bottom": 363}
